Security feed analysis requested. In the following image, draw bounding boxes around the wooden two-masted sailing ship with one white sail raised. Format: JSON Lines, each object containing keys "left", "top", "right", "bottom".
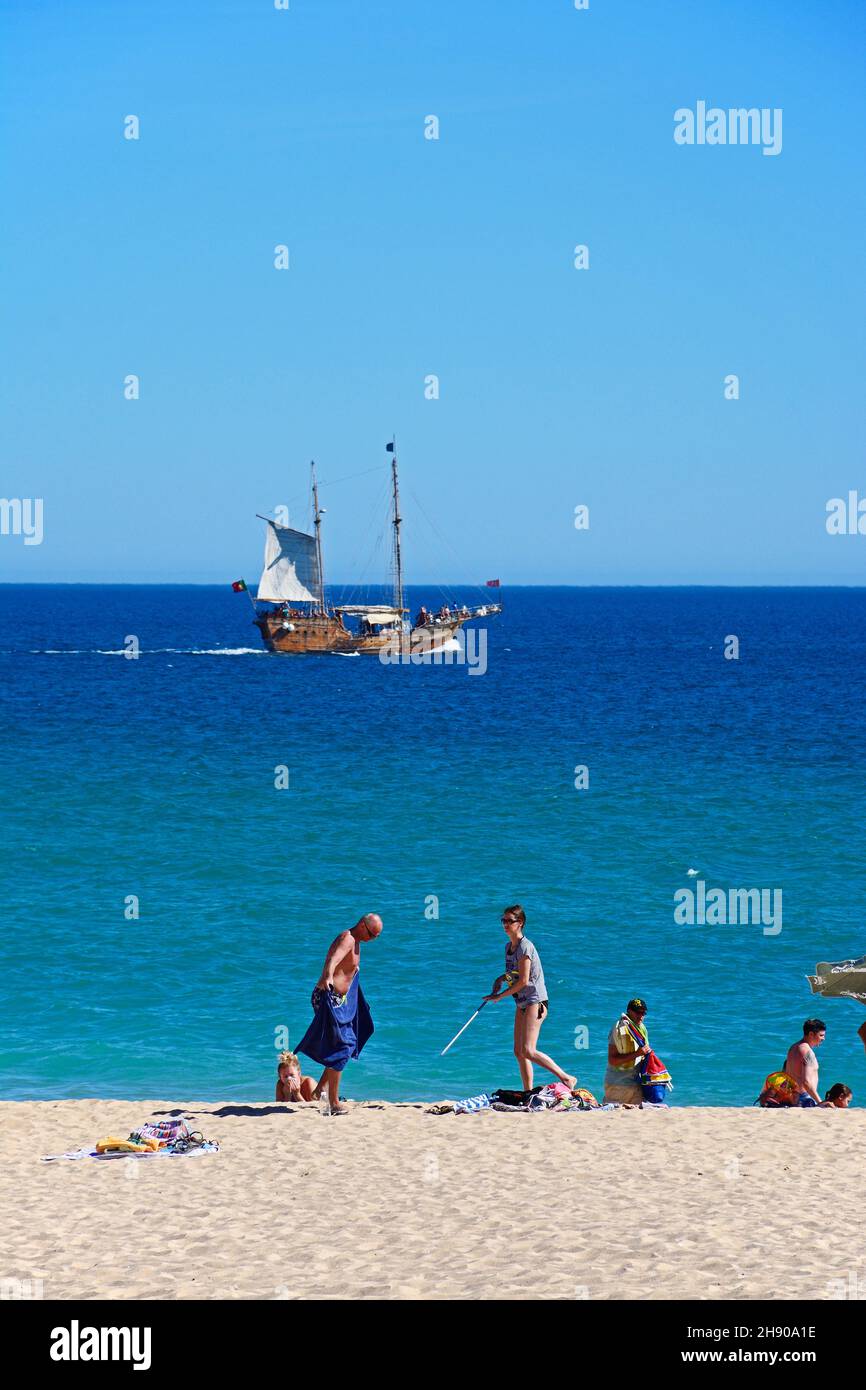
{"left": 244, "top": 442, "right": 502, "bottom": 653}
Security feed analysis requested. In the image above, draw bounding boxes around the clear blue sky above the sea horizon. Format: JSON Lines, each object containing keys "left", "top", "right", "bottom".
{"left": 0, "top": 0, "right": 866, "bottom": 584}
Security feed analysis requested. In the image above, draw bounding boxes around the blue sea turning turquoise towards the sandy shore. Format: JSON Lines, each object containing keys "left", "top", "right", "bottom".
{"left": 0, "top": 585, "right": 866, "bottom": 1104}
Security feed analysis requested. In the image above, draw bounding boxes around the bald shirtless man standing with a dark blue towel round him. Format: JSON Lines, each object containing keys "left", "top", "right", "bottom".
{"left": 297, "top": 912, "right": 382, "bottom": 1115}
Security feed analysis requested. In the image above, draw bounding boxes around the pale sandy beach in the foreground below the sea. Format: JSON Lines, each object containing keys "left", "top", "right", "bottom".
{"left": 0, "top": 1099, "right": 866, "bottom": 1300}
